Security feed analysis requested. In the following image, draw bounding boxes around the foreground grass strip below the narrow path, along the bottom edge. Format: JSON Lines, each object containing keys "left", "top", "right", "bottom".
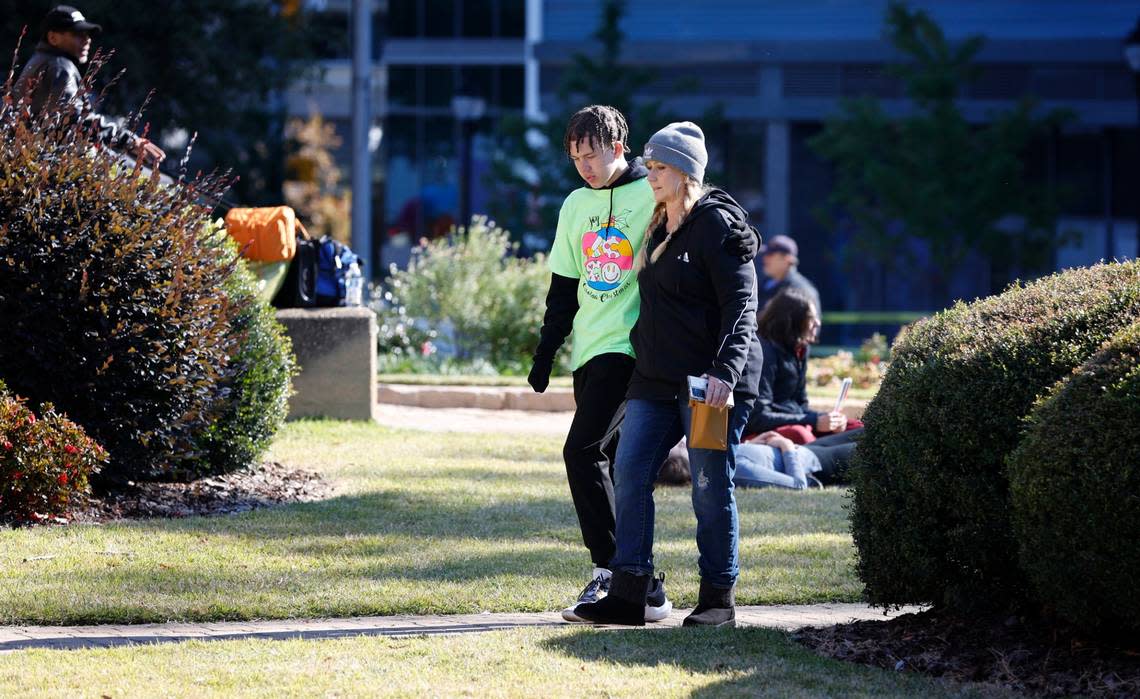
{"left": 0, "top": 627, "right": 1010, "bottom": 698}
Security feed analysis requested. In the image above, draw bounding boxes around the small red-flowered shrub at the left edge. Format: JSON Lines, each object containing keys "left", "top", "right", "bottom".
{"left": 0, "top": 382, "right": 107, "bottom": 525}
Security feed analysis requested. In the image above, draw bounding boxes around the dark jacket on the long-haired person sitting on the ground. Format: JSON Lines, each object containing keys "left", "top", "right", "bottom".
{"left": 744, "top": 338, "right": 820, "bottom": 434}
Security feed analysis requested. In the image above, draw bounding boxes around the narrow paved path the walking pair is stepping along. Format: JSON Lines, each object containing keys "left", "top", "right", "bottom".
{"left": 0, "top": 603, "right": 920, "bottom": 653}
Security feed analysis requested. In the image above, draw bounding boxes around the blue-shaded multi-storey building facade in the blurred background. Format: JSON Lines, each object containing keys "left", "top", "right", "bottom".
{"left": 293, "top": 0, "right": 1140, "bottom": 335}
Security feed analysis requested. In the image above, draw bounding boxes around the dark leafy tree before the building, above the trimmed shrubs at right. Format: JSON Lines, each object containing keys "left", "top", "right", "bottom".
{"left": 811, "top": 1, "right": 1066, "bottom": 293}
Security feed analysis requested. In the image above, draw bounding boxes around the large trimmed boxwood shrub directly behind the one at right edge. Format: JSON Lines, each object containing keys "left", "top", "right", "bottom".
{"left": 850, "top": 262, "right": 1140, "bottom": 609}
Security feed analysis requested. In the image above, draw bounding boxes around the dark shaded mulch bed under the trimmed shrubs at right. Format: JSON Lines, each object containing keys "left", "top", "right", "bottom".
{"left": 795, "top": 606, "right": 1140, "bottom": 698}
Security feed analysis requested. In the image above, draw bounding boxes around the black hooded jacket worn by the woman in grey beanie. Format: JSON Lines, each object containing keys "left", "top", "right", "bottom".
{"left": 627, "top": 189, "right": 764, "bottom": 400}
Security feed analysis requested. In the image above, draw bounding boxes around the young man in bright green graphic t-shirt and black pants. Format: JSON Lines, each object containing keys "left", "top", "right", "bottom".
{"left": 528, "top": 105, "right": 673, "bottom": 621}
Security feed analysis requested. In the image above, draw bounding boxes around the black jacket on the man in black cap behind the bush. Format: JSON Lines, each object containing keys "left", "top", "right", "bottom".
{"left": 14, "top": 41, "right": 139, "bottom": 152}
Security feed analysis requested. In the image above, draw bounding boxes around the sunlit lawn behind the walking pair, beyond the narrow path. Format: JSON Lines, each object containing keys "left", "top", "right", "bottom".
{"left": 0, "top": 422, "right": 860, "bottom": 624}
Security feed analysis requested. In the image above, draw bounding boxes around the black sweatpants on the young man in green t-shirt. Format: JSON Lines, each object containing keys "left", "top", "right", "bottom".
{"left": 562, "top": 353, "right": 634, "bottom": 568}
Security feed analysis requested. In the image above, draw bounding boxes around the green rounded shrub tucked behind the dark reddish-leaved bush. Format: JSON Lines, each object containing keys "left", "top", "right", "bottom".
{"left": 187, "top": 233, "right": 296, "bottom": 476}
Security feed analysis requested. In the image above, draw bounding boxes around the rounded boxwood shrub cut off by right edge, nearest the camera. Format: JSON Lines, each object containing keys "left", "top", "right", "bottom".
{"left": 1009, "top": 324, "right": 1140, "bottom": 632}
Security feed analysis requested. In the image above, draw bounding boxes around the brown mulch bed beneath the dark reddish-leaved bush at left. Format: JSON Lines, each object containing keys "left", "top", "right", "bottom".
{"left": 71, "top": 462, "right": 333, "bottom": 522}
